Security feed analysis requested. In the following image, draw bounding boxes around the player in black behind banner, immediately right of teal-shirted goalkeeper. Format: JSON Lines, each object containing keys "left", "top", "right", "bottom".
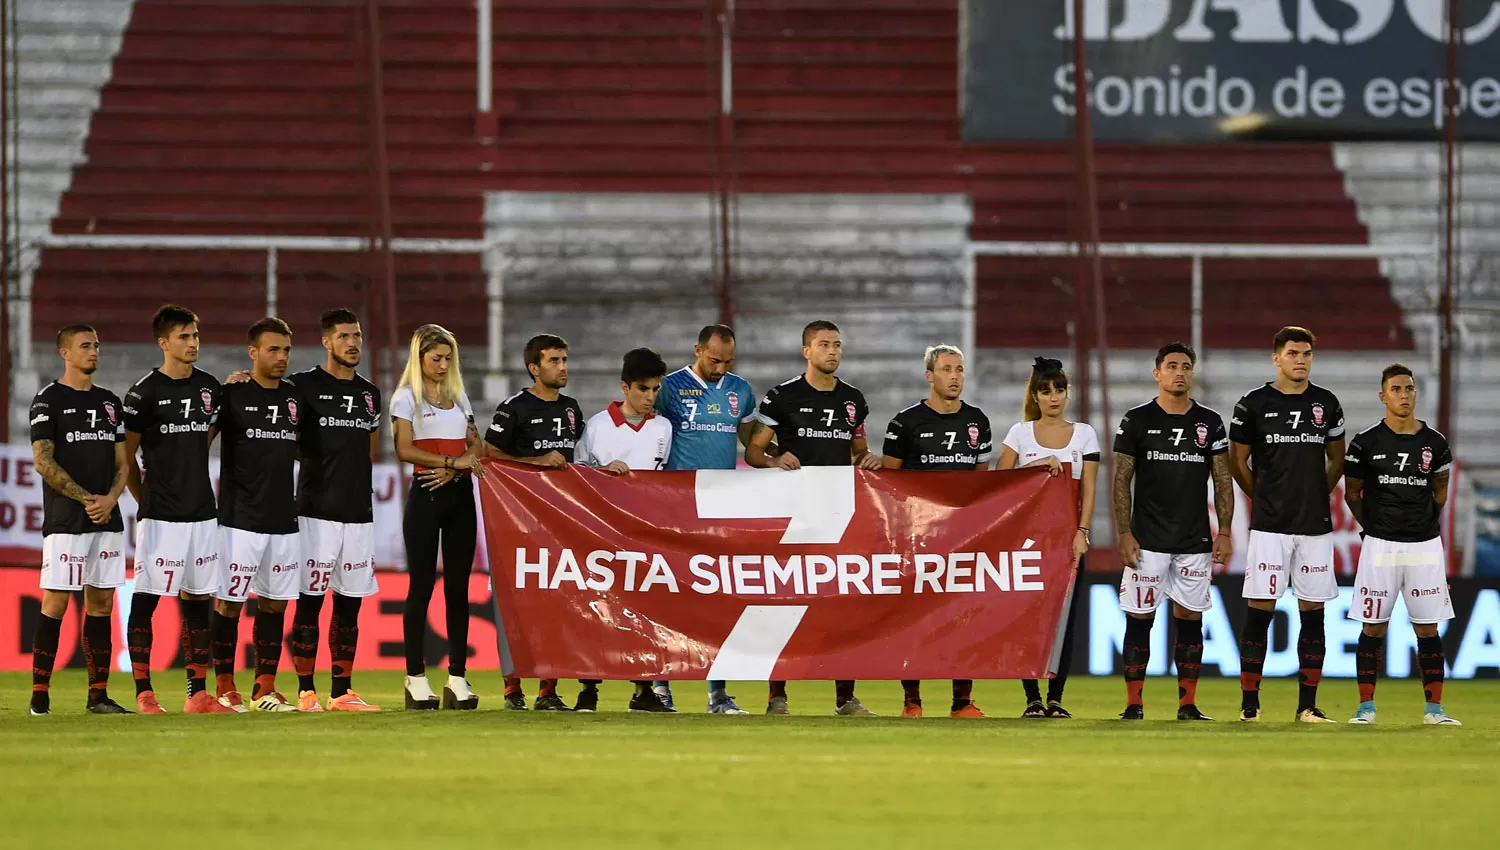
{"left": 746, "top": 319, "right": 882, "bottom": 717}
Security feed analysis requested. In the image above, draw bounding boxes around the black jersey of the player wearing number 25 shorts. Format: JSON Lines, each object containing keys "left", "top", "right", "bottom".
{"left": 291, "top": 366, "right": 381, "bottom": 523}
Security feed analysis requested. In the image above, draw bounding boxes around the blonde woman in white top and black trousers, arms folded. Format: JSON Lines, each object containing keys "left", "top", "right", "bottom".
{"left": 390, "top": 325, "right": 483, "bottom": 709}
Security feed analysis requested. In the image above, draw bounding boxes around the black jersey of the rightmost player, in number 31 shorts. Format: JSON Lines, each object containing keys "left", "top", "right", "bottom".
{"left": 1344, "top": 420, "right": 1454, "bottom": 543}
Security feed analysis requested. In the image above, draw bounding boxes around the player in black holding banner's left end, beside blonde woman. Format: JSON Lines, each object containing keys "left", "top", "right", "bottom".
{"left": 485, "top": 334, "right": 599, "bottom": 711}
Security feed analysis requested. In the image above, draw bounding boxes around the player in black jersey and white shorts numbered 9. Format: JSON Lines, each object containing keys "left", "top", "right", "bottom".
{"left": 1229, "top": 327, "right": 1344, "bottom": 723}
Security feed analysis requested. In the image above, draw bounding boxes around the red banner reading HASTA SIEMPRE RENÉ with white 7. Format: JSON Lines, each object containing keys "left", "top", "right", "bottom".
{"left": 480, "top": 462, "right": 1077, "bottom": 679}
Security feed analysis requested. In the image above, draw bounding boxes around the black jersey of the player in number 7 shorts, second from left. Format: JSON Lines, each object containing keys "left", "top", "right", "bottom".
{"left": 125, "top": 369, "right": 219, "bottom": 522}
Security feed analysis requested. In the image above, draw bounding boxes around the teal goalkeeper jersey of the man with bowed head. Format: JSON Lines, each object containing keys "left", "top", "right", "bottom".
{"left": 657, "top": 366, "right": 756, "bottom": 469}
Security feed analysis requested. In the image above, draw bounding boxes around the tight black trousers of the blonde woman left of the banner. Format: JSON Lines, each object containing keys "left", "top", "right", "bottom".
{"left": 402, "top": 475, "right": 479, "bottom": 676}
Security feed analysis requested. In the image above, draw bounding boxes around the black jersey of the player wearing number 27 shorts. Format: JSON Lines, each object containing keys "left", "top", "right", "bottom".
{"left": 219, "top": 381, "right": 301, "bottom": 534}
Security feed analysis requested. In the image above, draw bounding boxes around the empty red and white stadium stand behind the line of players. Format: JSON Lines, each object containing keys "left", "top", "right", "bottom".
{"left": 18, "top": 0, "right": 1488, "bottom": 473}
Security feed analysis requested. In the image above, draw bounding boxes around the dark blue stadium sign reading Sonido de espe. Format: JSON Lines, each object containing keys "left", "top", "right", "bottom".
{"left": 963, "top": 0, "right": 1500, "bottom": 141}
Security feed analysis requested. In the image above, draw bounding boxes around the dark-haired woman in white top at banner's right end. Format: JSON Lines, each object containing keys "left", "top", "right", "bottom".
{"left": 998, "top": 357, "right": 1100, "bottom": 718}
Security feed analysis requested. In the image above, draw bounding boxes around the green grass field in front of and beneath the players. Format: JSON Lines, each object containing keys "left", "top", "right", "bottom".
{"left": 0, "top": 672, "right": 1500, "bottom": 850}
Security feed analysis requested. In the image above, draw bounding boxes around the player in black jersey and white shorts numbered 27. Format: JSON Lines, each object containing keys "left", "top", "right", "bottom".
{"left": 213, "top": 318, "right": 306, "bottom": 712}
